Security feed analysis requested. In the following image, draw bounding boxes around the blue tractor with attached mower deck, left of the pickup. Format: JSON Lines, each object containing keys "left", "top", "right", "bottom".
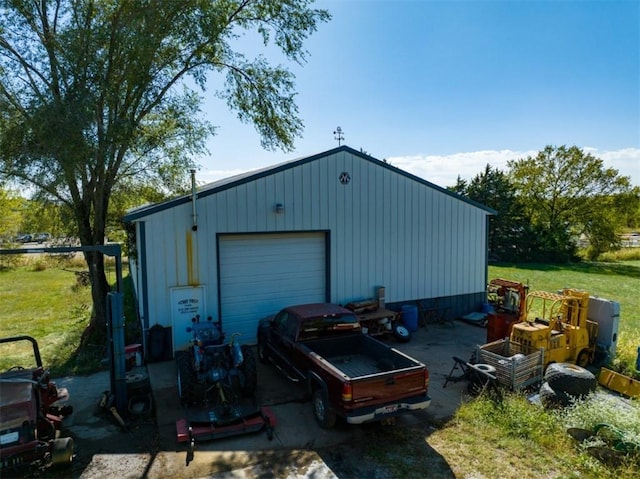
{"left": 175, "top": 316, "right": 275, "bottom": 462}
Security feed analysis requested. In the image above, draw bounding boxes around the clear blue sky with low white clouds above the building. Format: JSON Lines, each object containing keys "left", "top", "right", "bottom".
{"left": 198, "top": 0, "right": 640, "bottom": 186}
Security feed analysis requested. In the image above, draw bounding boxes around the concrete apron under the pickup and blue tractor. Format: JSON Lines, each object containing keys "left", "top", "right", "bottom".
{"left": 56, "top": 321, "right": 486, "bottom": 479}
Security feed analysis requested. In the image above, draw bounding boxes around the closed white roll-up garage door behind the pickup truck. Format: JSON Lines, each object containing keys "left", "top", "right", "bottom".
{"left": 219, "top": 233, "right": 327, "bottom": 344}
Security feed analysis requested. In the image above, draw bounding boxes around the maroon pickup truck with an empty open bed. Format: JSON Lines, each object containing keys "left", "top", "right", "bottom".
{"left": 258, "top": 303, "right": 431, "bottom": 429}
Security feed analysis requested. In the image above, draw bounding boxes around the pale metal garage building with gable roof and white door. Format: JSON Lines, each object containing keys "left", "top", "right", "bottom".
{"left": 124, "top": 146, "right": 495, "bottom": 351}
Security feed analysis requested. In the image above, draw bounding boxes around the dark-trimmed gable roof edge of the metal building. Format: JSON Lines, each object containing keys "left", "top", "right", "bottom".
{"left": 123, "top": 145, "right": 497, "bottom": 223}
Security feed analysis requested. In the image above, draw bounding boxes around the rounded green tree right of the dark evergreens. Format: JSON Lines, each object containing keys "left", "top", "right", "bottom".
{"left": 508, "top": 146, "right": 637, "bottom": 261}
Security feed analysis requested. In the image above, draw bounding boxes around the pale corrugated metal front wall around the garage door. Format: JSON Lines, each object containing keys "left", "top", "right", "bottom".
{"left": 132, "top": 151, "right": 488, "bottom": 334}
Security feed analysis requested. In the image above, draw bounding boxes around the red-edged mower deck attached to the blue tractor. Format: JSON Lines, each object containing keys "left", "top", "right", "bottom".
{"left": 176, "top": 406, "right": 276, "bottom": 442}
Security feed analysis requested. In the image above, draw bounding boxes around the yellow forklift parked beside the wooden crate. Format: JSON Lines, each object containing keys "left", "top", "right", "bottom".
{"left": 510, "top": 288, "right": 598, "bottom": 367}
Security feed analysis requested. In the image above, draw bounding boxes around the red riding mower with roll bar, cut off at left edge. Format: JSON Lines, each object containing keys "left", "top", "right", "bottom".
{"left": 0, "top": 336, "right": 73, "bottom": 476}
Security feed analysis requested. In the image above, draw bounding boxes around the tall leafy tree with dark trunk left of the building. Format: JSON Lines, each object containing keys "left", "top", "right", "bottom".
{"left": 0, "top": 0, "right": 329, "bottom": 344}
